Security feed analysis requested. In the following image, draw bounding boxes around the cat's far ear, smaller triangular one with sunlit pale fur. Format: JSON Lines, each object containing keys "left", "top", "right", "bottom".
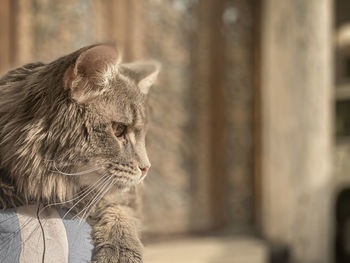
{"left": 121, "top": 61, "right": 161, "bottom": 94}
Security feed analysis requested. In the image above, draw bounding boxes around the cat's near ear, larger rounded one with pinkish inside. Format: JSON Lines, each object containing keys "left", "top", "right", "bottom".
{"left": 64, "top": 45, "right": 120, "bottom": 103}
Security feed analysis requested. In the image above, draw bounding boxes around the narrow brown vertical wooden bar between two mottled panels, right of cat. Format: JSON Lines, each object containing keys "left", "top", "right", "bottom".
{"left": 204, "top": 0, "right": 226, "bottom": 228}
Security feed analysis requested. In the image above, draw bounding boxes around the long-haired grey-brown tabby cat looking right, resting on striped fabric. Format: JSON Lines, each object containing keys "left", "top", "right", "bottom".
{"left": 0, "top": 44, "right": 159, "bottom": 263}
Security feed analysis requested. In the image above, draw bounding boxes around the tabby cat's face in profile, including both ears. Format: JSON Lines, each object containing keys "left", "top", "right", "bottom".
{"left": 64, "top": 46, "right": 158, "bottom": 188}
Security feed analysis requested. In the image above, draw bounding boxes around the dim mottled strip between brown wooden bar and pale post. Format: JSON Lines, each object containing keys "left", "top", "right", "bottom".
{"left": 222, "top": 0, "right": 256, "bottom": 233}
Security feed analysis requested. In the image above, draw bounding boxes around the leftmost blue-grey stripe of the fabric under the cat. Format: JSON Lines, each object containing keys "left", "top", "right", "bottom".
{"left": 0, "top": 209, "right": 22, "bottom": 263}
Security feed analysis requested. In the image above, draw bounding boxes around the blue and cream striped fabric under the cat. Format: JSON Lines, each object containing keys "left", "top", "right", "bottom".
{"left": 0, "top": 206, "right": 93, "bottom": 263}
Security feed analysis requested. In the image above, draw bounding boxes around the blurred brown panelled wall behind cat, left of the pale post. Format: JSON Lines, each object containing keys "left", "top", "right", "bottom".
{"left": 0, "top": 0, "right": 255, "bottom": 237}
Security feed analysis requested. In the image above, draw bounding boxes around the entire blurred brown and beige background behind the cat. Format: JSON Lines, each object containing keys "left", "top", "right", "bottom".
{"left": 0, "top": 0, "right": 350, "bottom": 263}
